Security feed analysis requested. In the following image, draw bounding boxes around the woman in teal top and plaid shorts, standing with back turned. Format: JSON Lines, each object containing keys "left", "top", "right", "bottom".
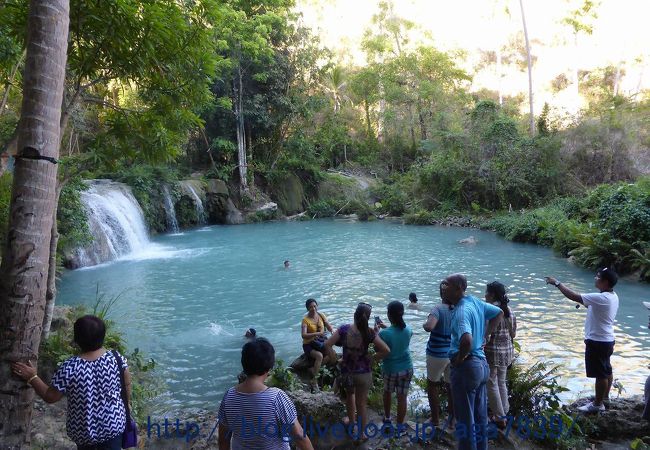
{"left": 379, "top": 301, "right": 413, "bottom": 430}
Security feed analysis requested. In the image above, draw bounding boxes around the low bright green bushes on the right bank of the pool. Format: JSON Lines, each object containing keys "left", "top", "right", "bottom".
{"left": 484, "top": 178, "right": 650, "bottom": 280}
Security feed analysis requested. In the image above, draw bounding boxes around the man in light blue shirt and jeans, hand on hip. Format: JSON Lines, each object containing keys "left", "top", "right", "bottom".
{"left": 442, "top": 274, "right": 503, "bottom": 450}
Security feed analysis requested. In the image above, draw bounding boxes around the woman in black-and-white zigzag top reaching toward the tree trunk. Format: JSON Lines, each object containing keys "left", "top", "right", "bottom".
{"left": 13, "top": 316, "right": 131, "bottom": 450}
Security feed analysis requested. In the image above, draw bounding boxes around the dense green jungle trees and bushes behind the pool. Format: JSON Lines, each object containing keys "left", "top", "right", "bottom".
{"left": 0, "top": 0, "right": 650, "bottom": 280}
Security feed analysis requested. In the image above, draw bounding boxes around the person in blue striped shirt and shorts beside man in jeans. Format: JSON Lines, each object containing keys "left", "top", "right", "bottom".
{"left": 424, "top": 284, "right": 454, "bottom": 427}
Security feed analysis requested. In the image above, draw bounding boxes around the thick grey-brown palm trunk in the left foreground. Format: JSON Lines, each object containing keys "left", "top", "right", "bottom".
{"left": 0, "top": 0, "right": 69, "bottom": 449}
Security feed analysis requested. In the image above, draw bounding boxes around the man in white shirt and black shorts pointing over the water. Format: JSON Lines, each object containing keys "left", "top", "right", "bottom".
{"left": 546, "top": 267, "right": 618, "bottom": 413}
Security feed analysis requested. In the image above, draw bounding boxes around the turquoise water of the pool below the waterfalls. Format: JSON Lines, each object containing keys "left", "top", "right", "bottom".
{"left": 57, "top": 220, "right": 650, "bottom": 411}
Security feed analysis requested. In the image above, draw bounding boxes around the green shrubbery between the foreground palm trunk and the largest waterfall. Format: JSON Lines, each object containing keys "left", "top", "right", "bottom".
{"left": 56, "top": 177, "right": 93, "bottom": 253}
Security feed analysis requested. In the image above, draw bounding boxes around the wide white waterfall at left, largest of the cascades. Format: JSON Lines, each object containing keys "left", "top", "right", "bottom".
{"left": 71, "top": 180, "right": 149, "bottom": 267}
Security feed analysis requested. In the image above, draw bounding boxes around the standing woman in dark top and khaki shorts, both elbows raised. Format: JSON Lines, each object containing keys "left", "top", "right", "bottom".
{"left": 325, "top": 302, "right": 390, "bottom": 440}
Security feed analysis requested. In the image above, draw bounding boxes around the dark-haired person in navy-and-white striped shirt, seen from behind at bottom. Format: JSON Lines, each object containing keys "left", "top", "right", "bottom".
{"left": 218, "top": 338, "right": 313, "bottom": 450}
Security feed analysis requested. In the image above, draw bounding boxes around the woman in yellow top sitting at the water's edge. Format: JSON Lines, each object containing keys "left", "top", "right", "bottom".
{"left": 301, "top": 298, "right": 336, "bottom": 377}
